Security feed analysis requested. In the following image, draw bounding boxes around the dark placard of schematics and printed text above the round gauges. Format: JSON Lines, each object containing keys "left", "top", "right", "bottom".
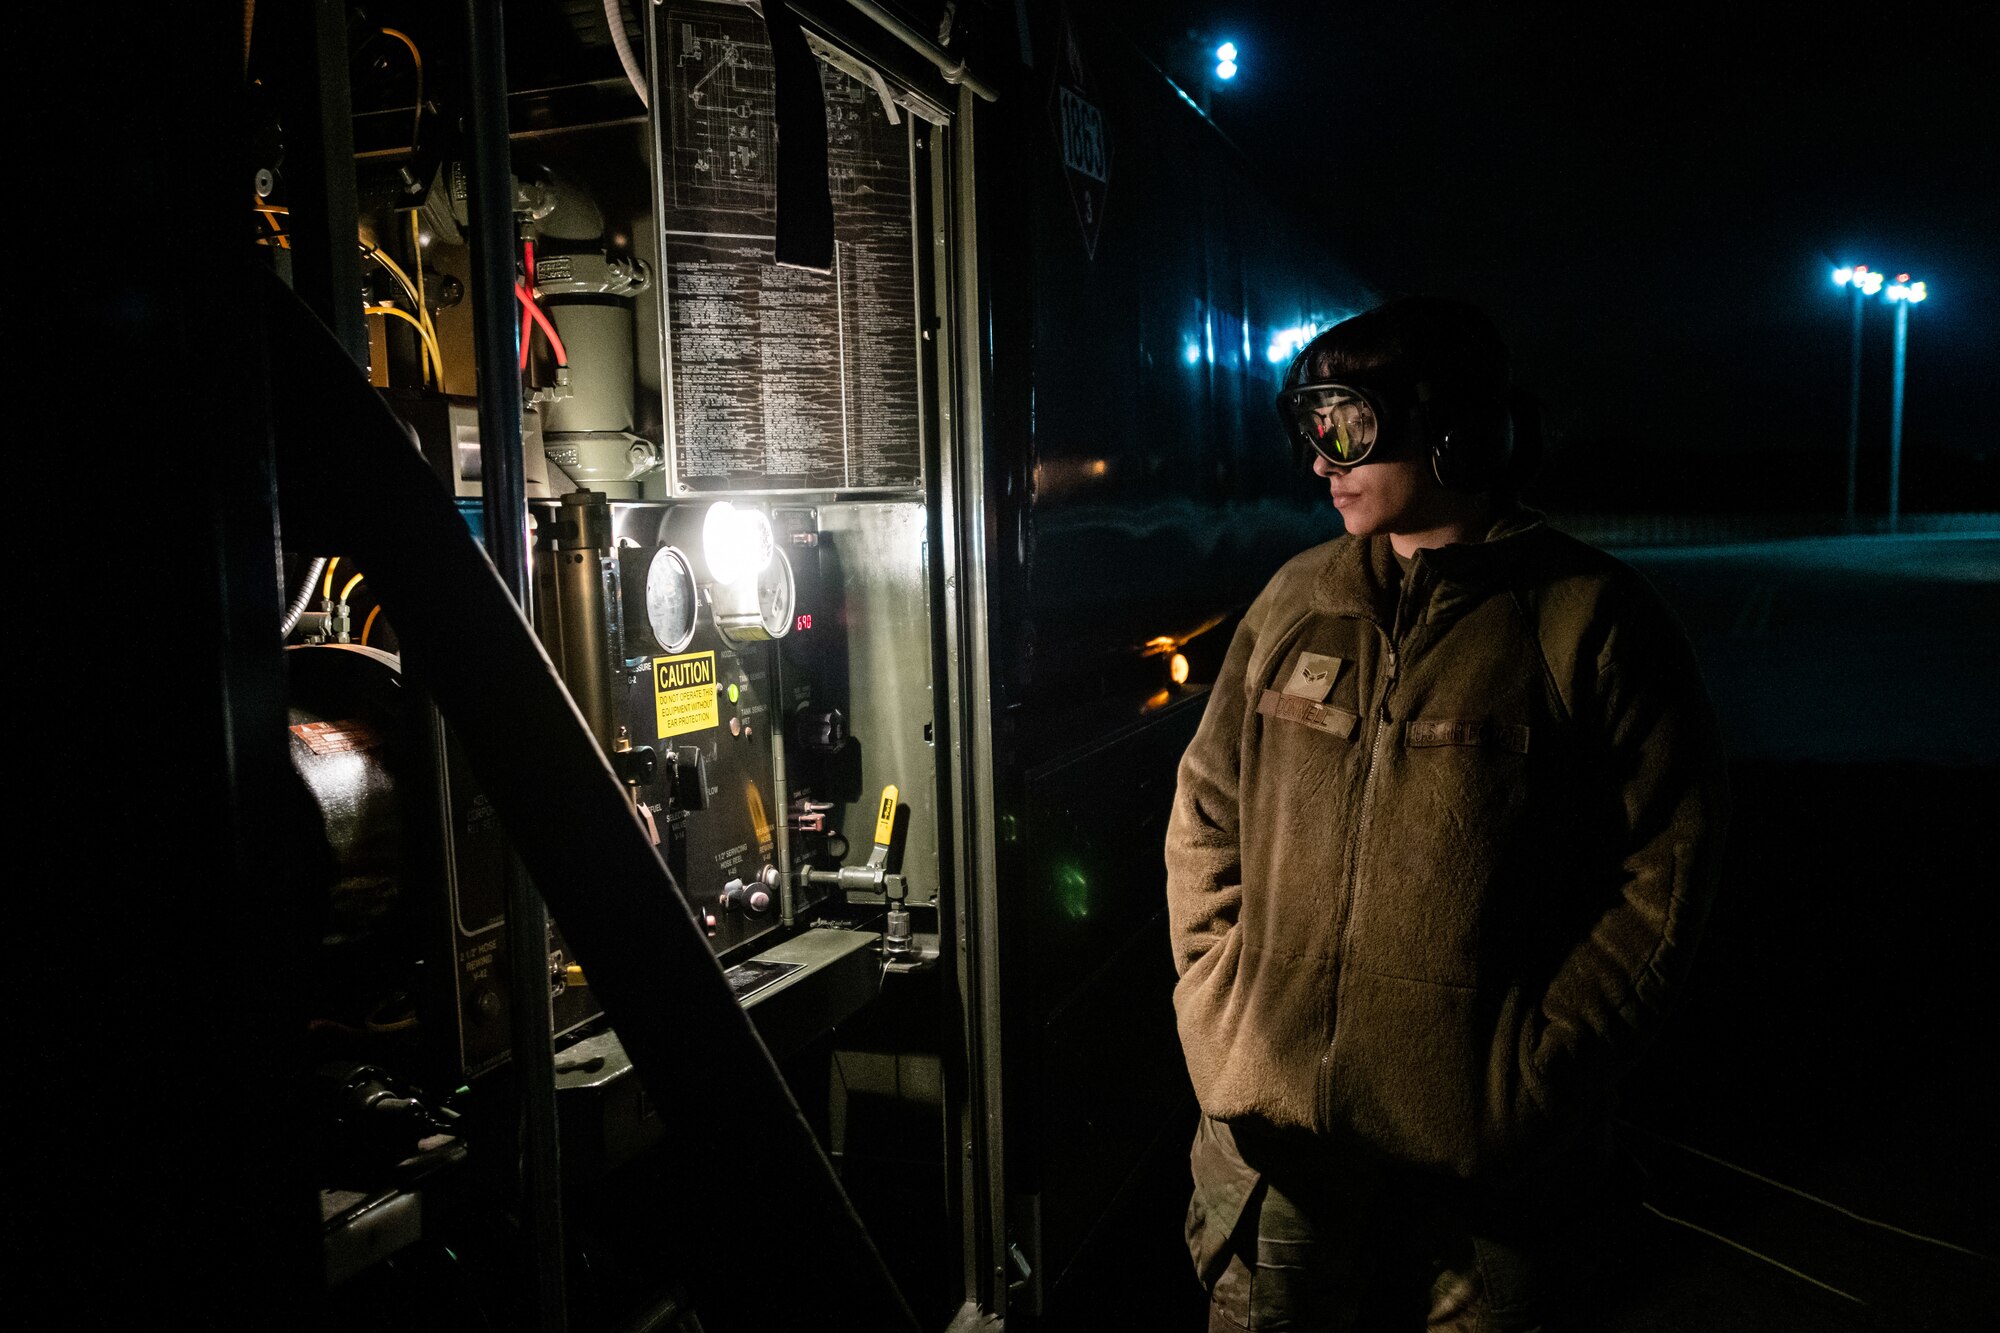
{"left": 660, "top": 4, "right": 924, "bottom": 494}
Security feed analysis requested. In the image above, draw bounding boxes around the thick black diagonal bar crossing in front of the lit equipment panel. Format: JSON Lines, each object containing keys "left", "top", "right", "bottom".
{"left": 262, "top": 262, "right": 918, "bottom": 1333}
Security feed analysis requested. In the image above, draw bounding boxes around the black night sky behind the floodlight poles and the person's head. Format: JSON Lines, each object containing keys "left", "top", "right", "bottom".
{"left": 1134, "top": 0, "right": 2000, "bottom": 512}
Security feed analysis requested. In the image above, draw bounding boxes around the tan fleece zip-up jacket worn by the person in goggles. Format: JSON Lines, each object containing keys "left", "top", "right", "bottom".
{"left": 1166, "top": 510, "right": 1724, "bottom": 1179}
